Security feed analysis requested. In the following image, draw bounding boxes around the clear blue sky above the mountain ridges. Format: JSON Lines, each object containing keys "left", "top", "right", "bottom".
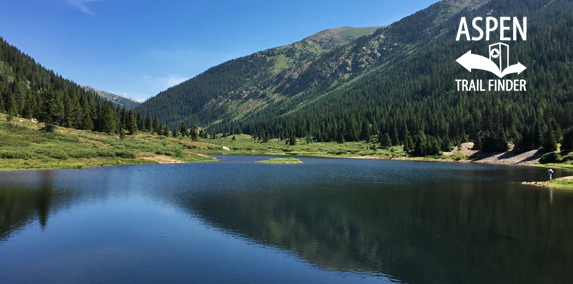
{"left": 0, "top": 0, "right": 437, "bottom": 100}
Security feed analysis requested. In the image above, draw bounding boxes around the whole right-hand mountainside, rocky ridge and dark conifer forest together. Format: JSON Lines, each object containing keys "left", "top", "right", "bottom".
{"left": 136, "top": 0, "right": 573, "bottom": 149}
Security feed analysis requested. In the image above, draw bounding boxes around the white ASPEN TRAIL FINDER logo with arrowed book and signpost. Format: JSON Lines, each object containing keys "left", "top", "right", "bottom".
{"left": 456, "top": 17, "right": 527, "bottom": 91}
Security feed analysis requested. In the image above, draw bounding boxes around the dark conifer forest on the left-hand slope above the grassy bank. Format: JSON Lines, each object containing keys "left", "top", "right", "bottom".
{"left": 0, "top": 38, "right": 163, "bottom": 134}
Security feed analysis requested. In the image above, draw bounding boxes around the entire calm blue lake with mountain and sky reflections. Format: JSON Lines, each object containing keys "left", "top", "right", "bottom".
{"left": 0, "top": 156, "right": 573, "bottom": 284}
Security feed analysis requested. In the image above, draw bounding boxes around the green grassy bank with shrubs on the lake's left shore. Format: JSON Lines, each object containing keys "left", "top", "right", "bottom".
{"left": 0, "top": 114, "right": 214, "bottom": 171}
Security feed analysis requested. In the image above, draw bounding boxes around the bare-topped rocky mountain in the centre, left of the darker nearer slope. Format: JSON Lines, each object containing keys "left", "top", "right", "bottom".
{"left": 136, "top": 27, "right": 380, "bottom": 126}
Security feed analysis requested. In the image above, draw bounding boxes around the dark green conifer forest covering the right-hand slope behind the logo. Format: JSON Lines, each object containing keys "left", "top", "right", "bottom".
{"left": 225, "top": 0, "right": 573, "bottom": 155}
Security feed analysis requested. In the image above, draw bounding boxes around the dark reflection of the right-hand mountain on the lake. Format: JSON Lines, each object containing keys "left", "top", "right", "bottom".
{"left": 181, "top": 170, "right": 573, "bottom": 283}
